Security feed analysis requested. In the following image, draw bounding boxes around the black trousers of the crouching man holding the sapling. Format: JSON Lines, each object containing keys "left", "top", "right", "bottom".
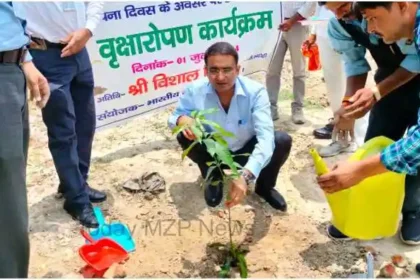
{"left": 177, "top": 131, "right": 292, "bottom": 193}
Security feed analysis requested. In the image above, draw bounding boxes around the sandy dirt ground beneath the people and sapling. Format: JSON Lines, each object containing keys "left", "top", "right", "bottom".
{"left": 28, "top": 52, "right": 420, "bottom": 278}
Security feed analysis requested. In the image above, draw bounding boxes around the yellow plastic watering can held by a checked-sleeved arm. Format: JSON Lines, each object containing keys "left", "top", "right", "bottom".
{"left": 326, "top": 136, "right": 405, "bottom": 240}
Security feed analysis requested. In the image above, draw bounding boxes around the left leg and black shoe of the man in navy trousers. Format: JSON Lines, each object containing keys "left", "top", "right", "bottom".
{"left": 31, "top": 49, "right": 98, "bottom": 227}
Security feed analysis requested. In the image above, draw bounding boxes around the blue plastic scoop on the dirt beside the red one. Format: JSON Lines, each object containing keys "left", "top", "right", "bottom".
{"left": 90, "top": 206, "right": 136, "bottom": 252}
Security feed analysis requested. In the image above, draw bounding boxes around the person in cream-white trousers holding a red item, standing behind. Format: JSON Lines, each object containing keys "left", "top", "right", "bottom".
{"left": 305, "top": 5, "right": 369, "bottom": 157}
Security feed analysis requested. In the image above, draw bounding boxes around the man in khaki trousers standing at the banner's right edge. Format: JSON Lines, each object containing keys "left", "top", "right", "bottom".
{"left": 266, "top": 2, "right": 316, "bottom": 124}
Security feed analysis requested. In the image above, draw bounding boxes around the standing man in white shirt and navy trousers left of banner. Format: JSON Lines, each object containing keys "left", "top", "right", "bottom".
{"left": 19, "top": 2, "right": 106, "bottom": 228}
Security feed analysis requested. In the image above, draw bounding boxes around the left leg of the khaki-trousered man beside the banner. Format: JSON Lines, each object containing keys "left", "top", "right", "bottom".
{"left": 265, "top": 33, "right": 287, "bottom": 121}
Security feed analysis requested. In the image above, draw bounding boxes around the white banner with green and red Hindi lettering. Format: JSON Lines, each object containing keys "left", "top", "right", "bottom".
{"left": 88, "top": 1, "right": 281, "bottom": 129}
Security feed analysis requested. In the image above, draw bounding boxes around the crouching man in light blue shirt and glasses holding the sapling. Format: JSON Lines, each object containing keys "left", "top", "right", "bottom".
{"left": 169, "top": 42, "right": 292, "bottom": 211}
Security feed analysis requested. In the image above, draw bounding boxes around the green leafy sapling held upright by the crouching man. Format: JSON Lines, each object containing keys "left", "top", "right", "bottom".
{"left": 172, "top": 109, "right": 248, "bottom": 278}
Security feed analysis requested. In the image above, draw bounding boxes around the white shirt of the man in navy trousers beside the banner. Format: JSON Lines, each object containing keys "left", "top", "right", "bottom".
{"left": 13, "top": 1, "right": 104, "bottom": 43}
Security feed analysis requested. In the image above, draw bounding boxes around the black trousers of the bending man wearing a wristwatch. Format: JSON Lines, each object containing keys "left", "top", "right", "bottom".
{"left": 365, "top": 69, "right": 420, "bottom": 213}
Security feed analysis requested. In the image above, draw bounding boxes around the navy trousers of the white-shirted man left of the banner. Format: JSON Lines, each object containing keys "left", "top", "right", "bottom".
{"left": 31, "top": 48, "right": 96, "bottom": 205}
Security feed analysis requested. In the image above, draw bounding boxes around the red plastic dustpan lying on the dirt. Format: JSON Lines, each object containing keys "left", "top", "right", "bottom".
{"left": 79, "top": 229, "right": 128, "bottom": 271}
